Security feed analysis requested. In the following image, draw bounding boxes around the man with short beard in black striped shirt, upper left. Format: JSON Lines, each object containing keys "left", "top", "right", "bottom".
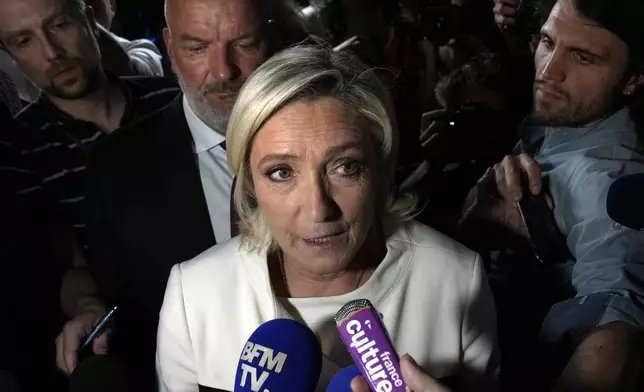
{"left": 0, "top": 0, "right": 178, "bottom": 251}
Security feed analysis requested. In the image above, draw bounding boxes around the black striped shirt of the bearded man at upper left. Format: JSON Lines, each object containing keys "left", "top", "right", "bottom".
{"left": 0, "top": 78, "right": 179, "bottom": 249}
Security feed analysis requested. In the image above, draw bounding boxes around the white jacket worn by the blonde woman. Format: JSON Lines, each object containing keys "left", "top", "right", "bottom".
{"left": 157, "top": 222, "right": 499, "bottom": 392}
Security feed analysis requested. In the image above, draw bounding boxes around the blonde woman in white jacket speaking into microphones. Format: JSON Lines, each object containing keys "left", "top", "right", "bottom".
{"left": 157, "top": 46, "right": 498, "bottom": 392}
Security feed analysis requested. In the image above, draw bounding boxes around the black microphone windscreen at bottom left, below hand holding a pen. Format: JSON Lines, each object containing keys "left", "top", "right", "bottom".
{"left": 69, "top": 355, "right": 129, "bottom": 392}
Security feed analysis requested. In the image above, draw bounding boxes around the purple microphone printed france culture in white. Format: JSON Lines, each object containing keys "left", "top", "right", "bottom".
{"left": 335, "top": 299, "right": 407, "bottom": 392}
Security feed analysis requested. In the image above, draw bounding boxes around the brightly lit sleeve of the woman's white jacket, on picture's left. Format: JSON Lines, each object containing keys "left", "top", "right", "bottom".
{"left": 156, "top": 264, "right": 199, "bottom": 392}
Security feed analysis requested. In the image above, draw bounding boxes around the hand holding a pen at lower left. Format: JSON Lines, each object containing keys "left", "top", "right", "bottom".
{"left": 56, "top": 310, "right": 110, "bottom": 375}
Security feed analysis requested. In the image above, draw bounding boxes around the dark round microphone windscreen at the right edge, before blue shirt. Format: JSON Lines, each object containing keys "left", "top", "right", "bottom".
{"left": 606, "top": 173, "right": 644, "bottom": 231}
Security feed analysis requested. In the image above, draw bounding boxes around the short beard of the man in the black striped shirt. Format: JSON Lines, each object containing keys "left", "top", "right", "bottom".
{"left": 39, "top": 60, "right": 100, "bottom": 100}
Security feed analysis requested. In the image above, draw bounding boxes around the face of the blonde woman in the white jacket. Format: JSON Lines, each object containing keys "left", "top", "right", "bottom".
{"left": 250, "top": 98, "right": 378, "bottom": 275}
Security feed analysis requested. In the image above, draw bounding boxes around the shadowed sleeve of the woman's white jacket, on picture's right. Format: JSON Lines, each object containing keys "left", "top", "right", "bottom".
{"left": 459, "top": 255, "right": 501, "bottom": 392}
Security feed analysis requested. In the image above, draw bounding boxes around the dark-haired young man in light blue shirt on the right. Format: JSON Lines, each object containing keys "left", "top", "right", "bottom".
{"left": 460, "top": 0, "right": 644, "bottom": 392}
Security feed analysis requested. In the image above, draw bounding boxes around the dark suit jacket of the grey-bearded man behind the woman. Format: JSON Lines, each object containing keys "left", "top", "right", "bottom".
{"left": 88, "top": 96, "right": 229, "bottom": 391}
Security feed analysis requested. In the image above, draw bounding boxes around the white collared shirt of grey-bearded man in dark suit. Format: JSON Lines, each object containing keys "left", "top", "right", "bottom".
{"left": 183, "top": 96, "right": 234, "bottom": 243}
